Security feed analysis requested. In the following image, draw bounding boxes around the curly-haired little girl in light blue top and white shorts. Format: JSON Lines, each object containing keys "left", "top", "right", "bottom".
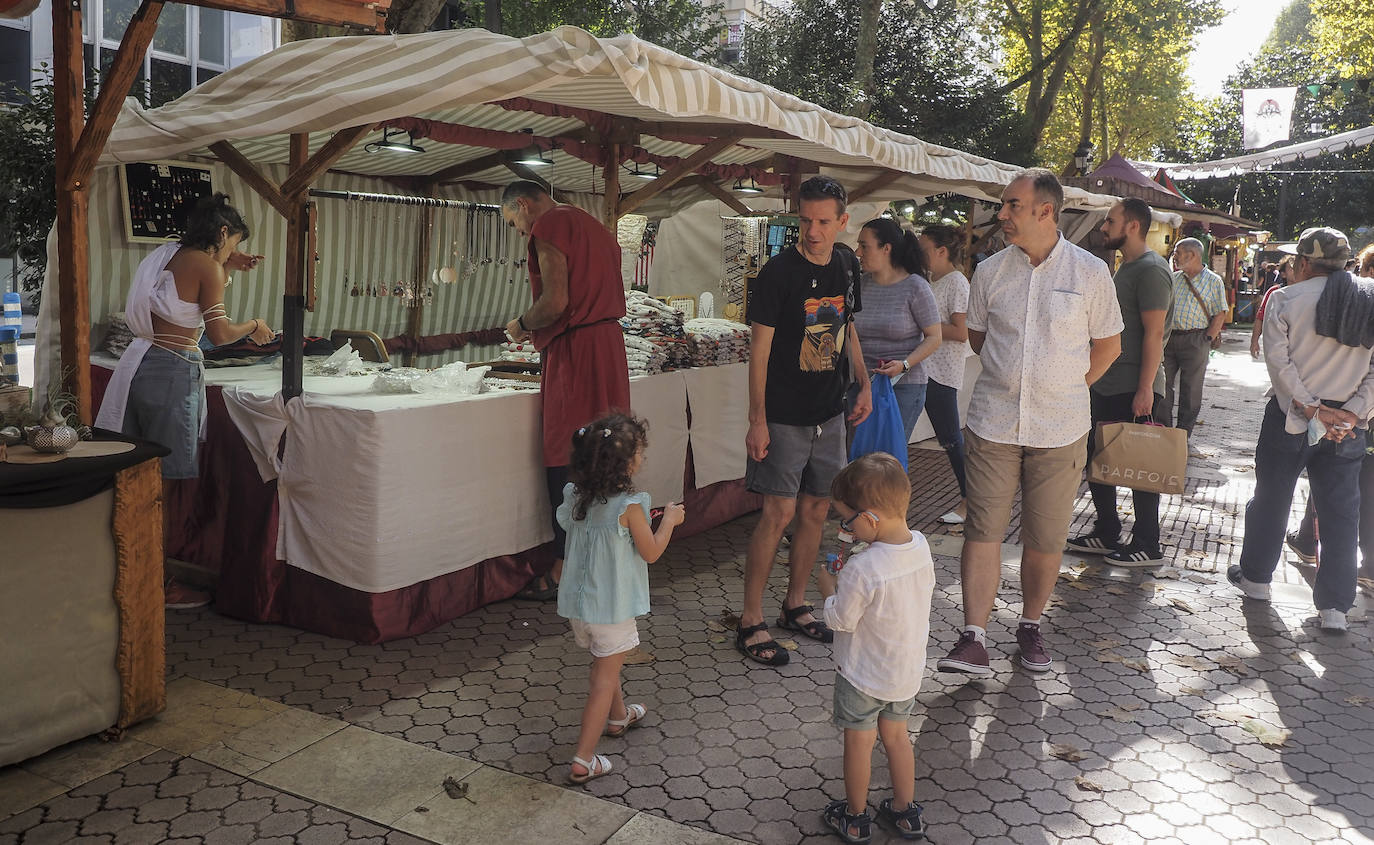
{"left": 556, "top": 414, "right": 686, "bottom": 783}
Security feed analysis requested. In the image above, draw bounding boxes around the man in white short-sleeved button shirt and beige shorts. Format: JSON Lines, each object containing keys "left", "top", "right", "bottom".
{"left": 937, "top": 168, "right": 1123, "bottom": 675}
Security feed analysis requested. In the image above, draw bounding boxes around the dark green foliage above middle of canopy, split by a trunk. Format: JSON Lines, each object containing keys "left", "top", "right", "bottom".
{"left": 735, "top": 0, "right": 1031, "bottom": 162}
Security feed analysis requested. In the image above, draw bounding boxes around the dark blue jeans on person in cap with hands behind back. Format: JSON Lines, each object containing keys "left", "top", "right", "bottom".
{"left": 1241, "top": 398, "right": 1364, "bottom": 613}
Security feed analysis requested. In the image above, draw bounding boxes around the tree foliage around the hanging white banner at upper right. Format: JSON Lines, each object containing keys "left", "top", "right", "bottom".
{"left": 1161, "top": 0, "right": 1374, "bottom": 242}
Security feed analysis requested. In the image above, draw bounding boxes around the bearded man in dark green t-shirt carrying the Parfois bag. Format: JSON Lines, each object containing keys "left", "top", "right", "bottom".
{"left": 1069, "top": 196, "right": 1173, "bottom": 566}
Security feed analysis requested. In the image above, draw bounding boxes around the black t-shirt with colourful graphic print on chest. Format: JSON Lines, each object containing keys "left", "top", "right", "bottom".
{"left": 749, "top": 249, "right": 860, "bottom": 426}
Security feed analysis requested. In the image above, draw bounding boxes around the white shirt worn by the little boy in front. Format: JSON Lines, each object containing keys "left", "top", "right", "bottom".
{"left": 822, "top": 532, "right": 936, "bottom": 701}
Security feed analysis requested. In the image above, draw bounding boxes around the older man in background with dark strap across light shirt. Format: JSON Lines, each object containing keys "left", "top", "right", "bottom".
{"left": 1160, "top": 238, "right": 1227, "bottom": 458}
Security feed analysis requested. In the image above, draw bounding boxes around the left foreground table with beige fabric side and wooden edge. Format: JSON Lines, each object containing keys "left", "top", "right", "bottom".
{"left": 0, "top": 431, "right": 166, "bottom": 765}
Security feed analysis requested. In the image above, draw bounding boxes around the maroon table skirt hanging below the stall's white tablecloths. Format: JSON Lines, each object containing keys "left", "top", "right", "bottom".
{"left": 91, "top": 365, "right": 763, "bottom": 643}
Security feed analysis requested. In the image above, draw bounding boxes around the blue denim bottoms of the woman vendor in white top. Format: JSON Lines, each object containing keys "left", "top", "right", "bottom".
{"left": 124, "top": 346, "right": 202, "bottom": 478}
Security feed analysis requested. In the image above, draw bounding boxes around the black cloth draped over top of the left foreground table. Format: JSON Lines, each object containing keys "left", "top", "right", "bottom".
{"left": 0, "top": 429, "right": 170, "bottom": 510}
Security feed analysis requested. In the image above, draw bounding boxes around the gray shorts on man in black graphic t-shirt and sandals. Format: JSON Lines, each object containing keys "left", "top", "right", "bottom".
{"left": 745, "top": 414, "right": 846, "bottom": 499}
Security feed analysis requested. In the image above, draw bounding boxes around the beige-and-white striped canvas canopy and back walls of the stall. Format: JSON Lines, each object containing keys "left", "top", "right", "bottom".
{"left": 38, "top": 27, "right": 1137, "bottom": 395}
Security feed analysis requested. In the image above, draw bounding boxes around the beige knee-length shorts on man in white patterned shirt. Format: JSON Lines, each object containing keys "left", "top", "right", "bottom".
{"left": 963, "top": 430, "right": 1088, "bottom": 554}
